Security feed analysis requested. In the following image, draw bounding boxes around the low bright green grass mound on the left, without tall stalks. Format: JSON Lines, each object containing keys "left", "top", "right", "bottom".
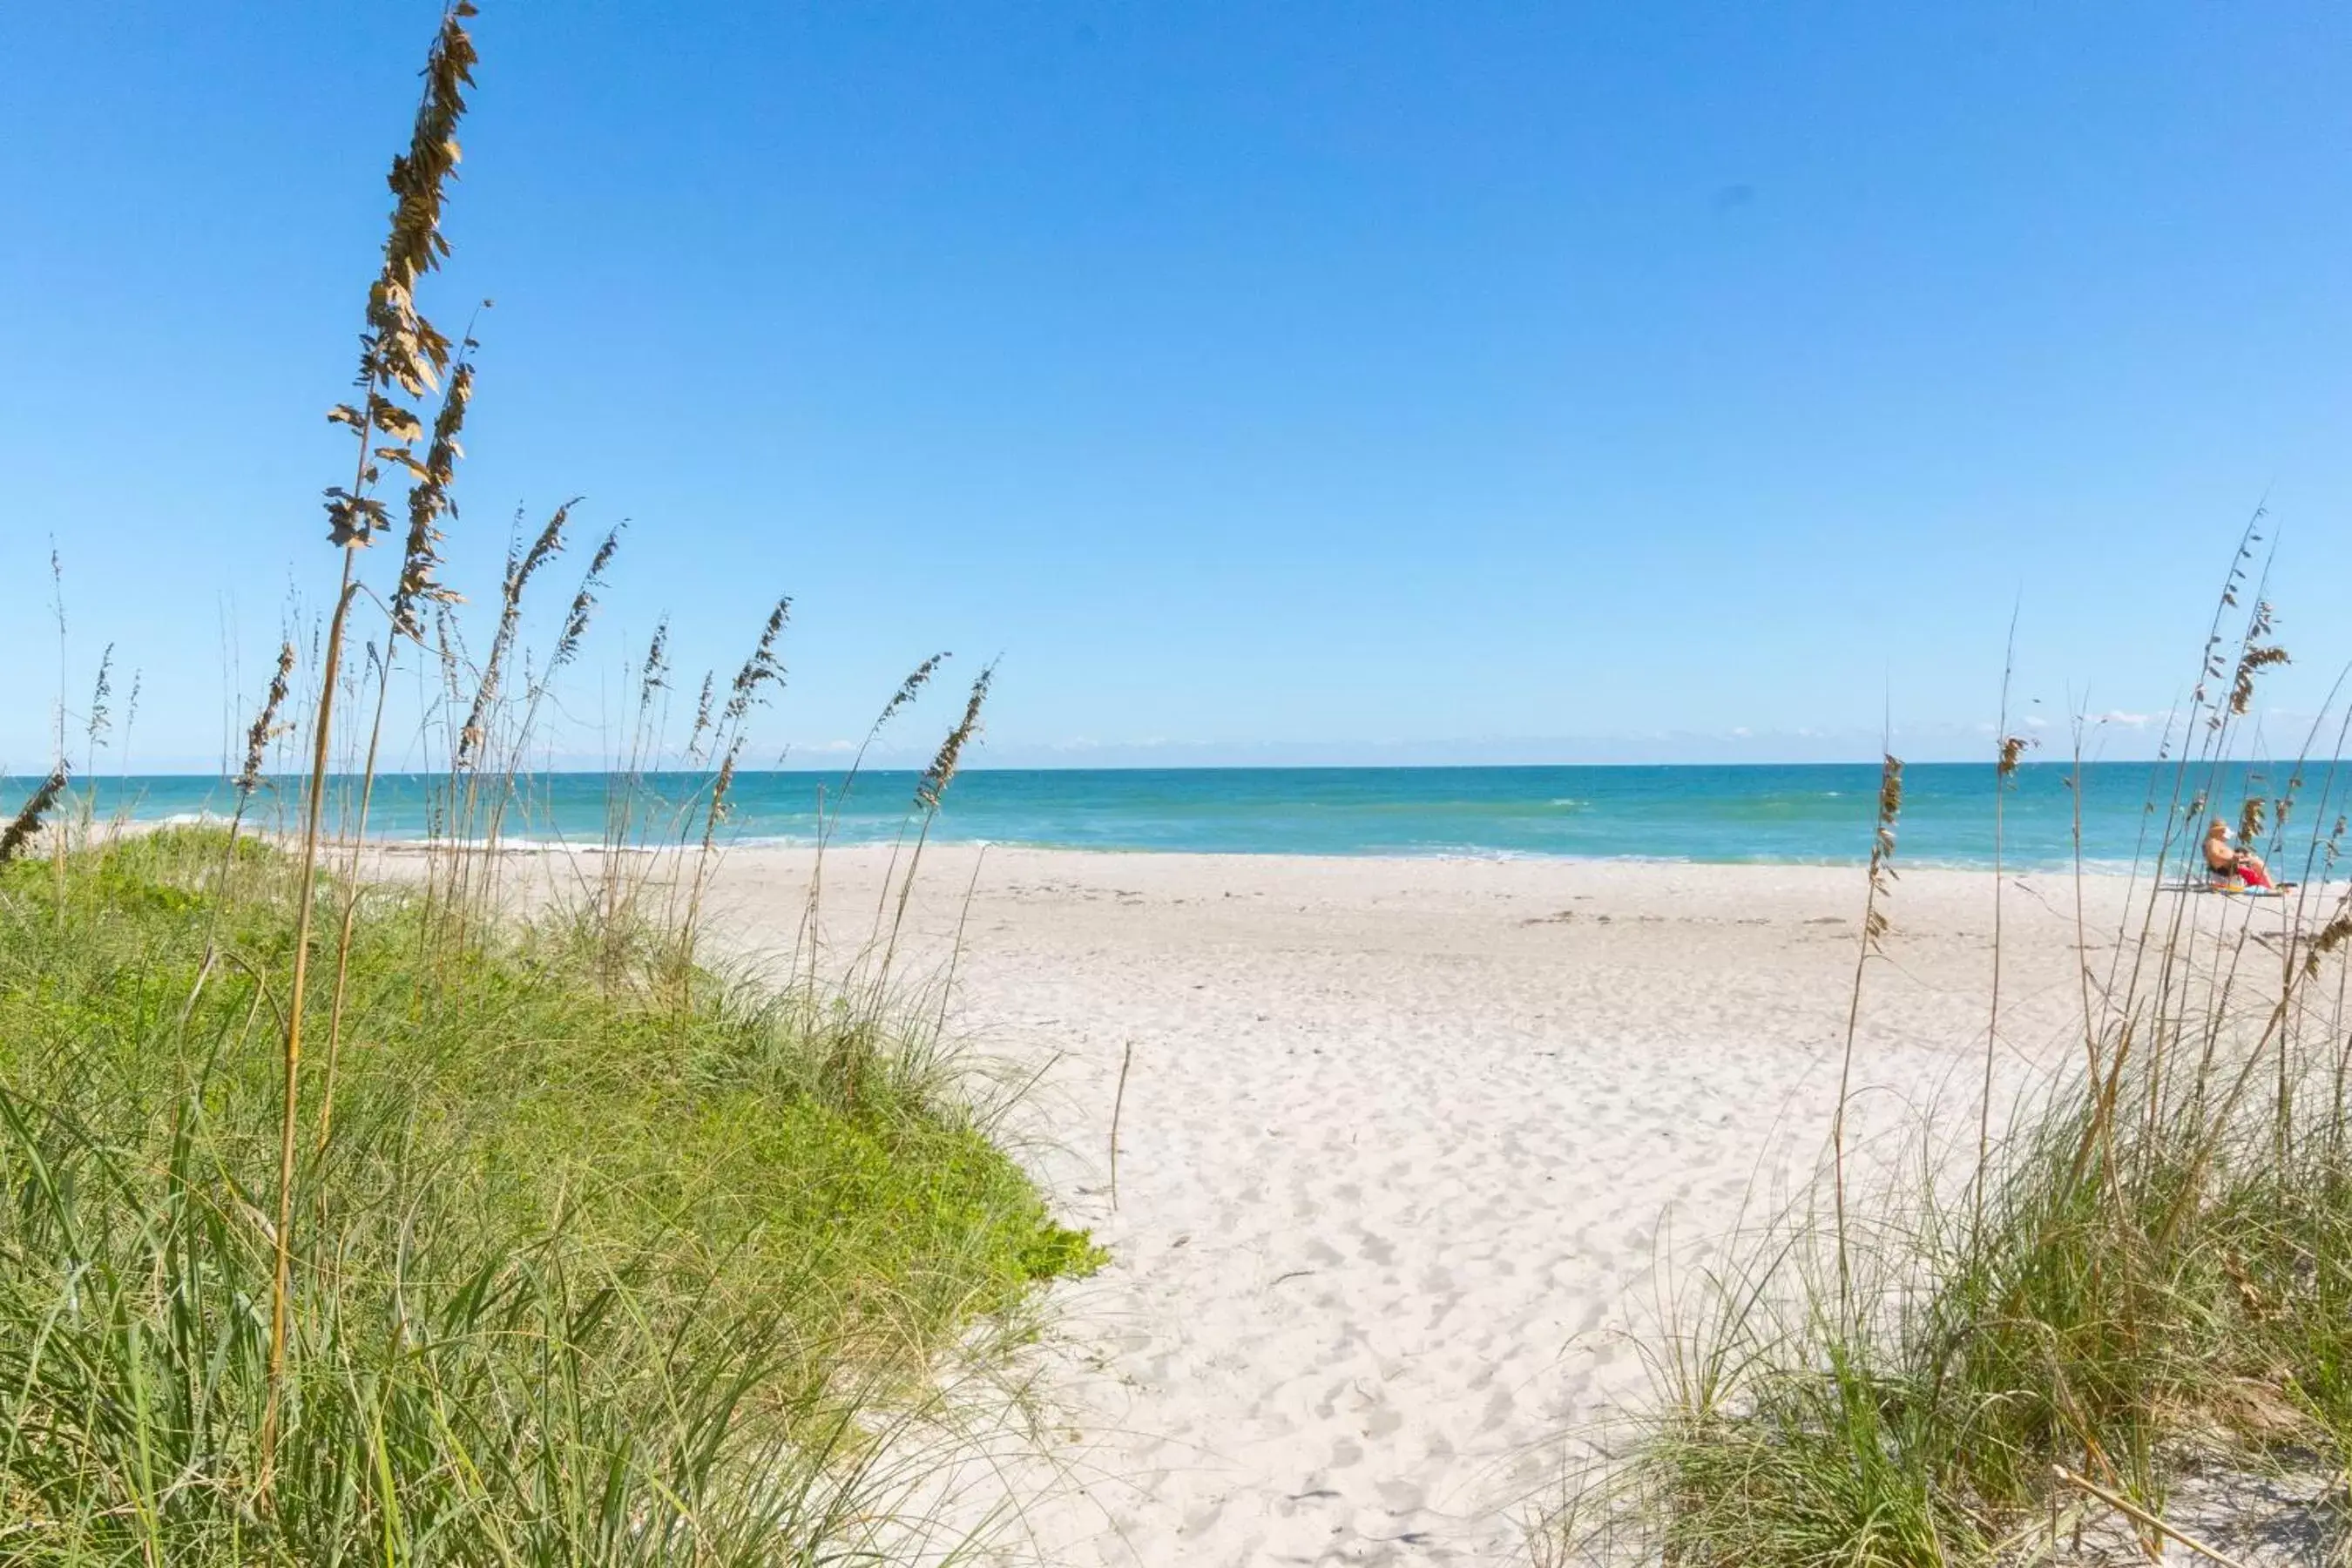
{"left": 0, "top": 830, "right": 1096, "bottom": 1564}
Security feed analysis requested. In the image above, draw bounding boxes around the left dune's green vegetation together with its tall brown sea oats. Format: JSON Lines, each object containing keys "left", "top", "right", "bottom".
{"left": 0, "top": 3, "right": 1098, "bottom": 1565}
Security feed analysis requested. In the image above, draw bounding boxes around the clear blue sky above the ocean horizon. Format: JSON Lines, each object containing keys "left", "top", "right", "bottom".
{"left": 0, "top": 0, "right": 2352, "bottom": 768}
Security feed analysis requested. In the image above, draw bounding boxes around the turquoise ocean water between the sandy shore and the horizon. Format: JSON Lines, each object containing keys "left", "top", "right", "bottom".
{"left": 7, "top": 761, "right": 2323, "bottom": 868}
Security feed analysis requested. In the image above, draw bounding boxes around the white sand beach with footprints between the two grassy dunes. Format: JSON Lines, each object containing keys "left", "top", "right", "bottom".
{"left": 677, "top": 847, "right": 2201, "bottom": 1565}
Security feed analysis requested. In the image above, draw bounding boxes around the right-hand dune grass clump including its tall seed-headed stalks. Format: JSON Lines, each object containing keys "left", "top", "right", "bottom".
{"left": 1538, "top": 529, "right": 2352, "bottom": 1568}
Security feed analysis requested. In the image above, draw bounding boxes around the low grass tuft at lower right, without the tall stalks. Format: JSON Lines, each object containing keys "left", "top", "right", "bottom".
{"left": 1555, "top": 1048, "right": 2352, "bottom": 1565}
